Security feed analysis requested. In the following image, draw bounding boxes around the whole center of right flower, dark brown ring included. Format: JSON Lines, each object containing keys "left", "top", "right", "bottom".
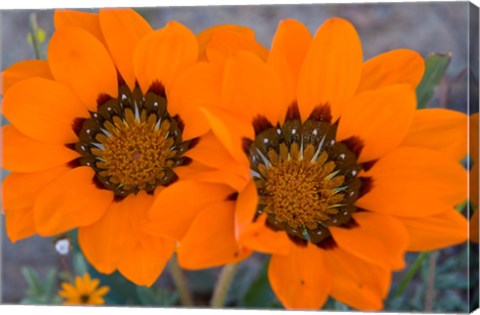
{"left": 244, "top": 105, "right": 362, "bottom": 245}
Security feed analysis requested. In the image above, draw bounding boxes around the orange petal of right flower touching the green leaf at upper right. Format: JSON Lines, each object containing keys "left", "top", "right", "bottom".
{"left": 357, "top": 49, "right": 425, "bottom": 93}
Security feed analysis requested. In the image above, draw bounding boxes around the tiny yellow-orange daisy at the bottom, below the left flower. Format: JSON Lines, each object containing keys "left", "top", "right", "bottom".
{"left": 58, "top": 273, "right": 110, "bottom": 305}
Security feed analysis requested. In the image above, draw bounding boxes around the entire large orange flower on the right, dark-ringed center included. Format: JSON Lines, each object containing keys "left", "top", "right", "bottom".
{"left": 179, "top": 18, "right": 467, "bottom": 310}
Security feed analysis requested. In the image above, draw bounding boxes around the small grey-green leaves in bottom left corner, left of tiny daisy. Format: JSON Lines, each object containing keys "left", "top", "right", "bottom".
{"left": 20, "top": 267, "right": 62, "bottom": 305}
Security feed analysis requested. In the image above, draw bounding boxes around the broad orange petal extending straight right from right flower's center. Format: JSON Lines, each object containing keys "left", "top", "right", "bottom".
{"left": 355, "top": 147, "right": 468, "bottom": 217}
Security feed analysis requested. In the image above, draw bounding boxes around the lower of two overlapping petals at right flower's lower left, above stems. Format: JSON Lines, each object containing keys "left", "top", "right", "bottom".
{"left": 177, "top": 201, "right": 250, "bottom": 269}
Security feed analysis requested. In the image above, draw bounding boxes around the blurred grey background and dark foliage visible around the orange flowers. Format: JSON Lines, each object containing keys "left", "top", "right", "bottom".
{"left": 0, "top": 2, "right": 478, "bottom": 312}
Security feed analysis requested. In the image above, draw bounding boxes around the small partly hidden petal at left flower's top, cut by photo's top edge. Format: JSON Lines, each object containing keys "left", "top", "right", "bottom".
{"left": 53, "top": 10, "right": 105, "bottom": 43}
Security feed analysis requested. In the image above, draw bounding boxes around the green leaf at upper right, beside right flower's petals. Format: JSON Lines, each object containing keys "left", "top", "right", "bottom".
{"left": 417, "top": 53, "right": 452, "bottom": 109}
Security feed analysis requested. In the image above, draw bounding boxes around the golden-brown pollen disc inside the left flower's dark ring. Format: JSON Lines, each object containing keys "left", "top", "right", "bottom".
{"left": 92, "top": 109, "right": 176, "bottom": 190}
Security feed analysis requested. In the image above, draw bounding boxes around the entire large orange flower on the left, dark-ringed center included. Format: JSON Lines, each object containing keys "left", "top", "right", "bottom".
{"left": 2, "top": 10, "right": 248, "bottom": 285}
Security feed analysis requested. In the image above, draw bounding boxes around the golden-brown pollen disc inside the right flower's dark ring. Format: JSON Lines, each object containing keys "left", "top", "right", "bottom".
{"left": 259, "top": 143, "right": 344, "bottom": 230}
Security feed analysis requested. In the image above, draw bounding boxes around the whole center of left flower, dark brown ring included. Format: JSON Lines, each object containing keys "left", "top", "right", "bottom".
{"left": 75, "top": 85, "right": 192, "bottom": 197}
